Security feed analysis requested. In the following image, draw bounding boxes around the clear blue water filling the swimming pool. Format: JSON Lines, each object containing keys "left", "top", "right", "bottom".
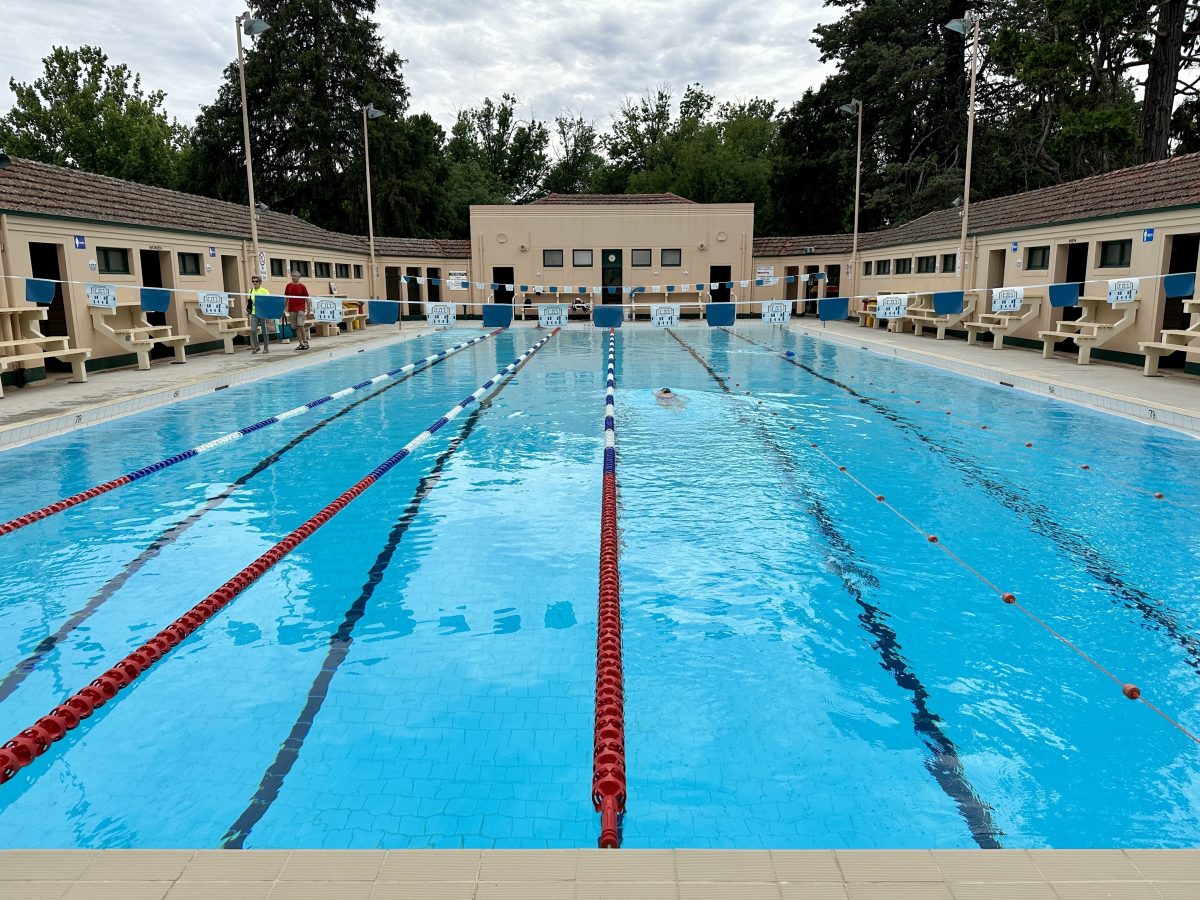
{"left": 0, "top": 325, "right": 1200, "bottom": 848}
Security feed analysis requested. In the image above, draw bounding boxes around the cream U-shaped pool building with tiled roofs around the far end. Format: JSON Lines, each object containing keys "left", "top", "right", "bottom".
{"left": 0, "top": 148, "right": 1200, "bottom": 383}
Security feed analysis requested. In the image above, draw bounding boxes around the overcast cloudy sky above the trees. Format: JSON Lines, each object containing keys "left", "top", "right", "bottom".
{"left": 0, "top": 0, "right": 836, "bottom": 137}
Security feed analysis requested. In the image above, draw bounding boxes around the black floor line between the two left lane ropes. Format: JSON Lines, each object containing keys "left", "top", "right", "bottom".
{"left": 0, "top": 348, "right": 463, "bottom": 703}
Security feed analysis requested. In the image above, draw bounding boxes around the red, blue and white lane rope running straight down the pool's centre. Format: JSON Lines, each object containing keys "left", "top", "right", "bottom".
{"left": 592, "top": 329, "right": 625, "bottom": 850}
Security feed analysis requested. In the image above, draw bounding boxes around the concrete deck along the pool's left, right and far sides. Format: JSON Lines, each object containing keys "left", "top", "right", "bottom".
{"left": 0, "top": 318, "right": 1200, "bottom": 450}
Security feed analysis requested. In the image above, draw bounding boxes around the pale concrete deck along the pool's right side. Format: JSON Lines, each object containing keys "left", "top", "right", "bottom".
{"left": 790, "top": 319, "right": 1200, "bottom": 437}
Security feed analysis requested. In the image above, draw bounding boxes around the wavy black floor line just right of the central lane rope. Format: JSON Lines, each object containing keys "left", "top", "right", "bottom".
{"left": 667, "top": 329, "right": 1003, "bottom": 850}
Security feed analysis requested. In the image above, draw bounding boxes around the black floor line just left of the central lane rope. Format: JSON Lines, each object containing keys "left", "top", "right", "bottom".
{"left": 221, "top": 348, "right": 532, "bottom": 850}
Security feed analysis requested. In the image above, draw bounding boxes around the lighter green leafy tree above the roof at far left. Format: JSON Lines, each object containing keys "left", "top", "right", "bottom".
{"left": 0, "top": 47, "right": 186, "bottom": 187}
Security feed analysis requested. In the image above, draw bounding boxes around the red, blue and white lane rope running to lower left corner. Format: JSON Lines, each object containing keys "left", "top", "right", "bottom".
{"left": 0, "top": 328, "right": 560, "bottom": 784}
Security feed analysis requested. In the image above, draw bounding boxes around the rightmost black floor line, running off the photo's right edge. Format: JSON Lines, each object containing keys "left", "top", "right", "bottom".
{"left": 722, "top": 329, "right": 1200, "bottom": 672}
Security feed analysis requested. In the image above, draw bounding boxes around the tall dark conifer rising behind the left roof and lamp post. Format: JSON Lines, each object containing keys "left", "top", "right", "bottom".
{"left": 187, "top": 0, "right": 408, "bottom": 233}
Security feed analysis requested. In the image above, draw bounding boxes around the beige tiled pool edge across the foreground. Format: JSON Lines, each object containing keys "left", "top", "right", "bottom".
{"left": 0, "top": 850, "right": 1200, "bottom": 900}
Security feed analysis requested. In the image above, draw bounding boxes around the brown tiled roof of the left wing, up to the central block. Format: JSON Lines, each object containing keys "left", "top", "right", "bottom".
{"left": 0, "top": 157, "right": 470, "bottom": 257}
